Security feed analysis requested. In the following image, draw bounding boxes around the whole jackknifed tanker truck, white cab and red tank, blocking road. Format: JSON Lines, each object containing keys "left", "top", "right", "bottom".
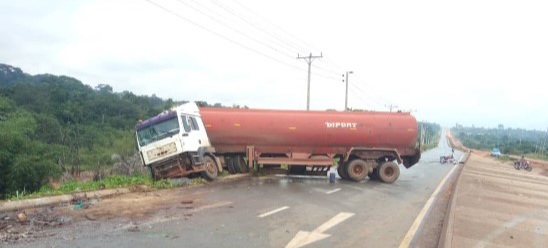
{"left": 136, "top": 103, "right": 421, "bottom": 183}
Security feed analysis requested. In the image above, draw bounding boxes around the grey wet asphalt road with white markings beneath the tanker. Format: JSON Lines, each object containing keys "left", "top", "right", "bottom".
{"left": 7, "top": 136, "right": 461, "bottom": 248}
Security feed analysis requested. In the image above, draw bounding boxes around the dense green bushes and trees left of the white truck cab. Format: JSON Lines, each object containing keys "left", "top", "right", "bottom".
{"left": 0, "top": 64, "right": 180, "bottom": 198}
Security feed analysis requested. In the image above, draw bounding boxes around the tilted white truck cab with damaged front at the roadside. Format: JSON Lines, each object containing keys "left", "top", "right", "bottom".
{"left": 136, "top": 103, "right": 220, "bottom": 179}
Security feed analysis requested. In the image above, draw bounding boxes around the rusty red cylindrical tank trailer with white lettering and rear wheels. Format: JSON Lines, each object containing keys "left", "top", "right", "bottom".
{"left": 199, "top": 108, "right": 420, "bottom": 183}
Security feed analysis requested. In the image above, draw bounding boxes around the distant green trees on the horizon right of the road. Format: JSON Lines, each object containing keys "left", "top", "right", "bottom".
{"left": 451, "top": 125, "right": 548, "bottom": 160}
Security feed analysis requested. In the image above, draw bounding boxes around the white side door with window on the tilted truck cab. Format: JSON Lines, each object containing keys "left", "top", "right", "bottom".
{"left": 181, "top": 115, "right": 209, "bottom": 152}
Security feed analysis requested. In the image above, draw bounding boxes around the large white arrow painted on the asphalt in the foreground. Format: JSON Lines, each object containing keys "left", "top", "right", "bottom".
{"left": 285, "top": 212, "right": 354, "bottom": 248}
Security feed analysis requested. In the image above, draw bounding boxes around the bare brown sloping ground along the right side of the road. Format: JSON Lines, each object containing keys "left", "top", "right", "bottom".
{"left": 440, "top": 152, "right": 548, "bottom": 247}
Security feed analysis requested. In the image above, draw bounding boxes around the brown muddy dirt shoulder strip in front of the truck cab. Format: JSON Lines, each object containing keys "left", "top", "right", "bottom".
{"left": 0, "top": 174, "right": 248, "bottom": 243}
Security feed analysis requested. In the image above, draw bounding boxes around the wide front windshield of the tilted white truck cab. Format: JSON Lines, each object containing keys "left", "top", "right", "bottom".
{"left": 137, "top": 116, "right": 179, "bottom": 146}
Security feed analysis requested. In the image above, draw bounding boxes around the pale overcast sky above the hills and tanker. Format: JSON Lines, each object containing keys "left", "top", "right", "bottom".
{"left": 0, "top": 0, "right": 548, "bottom": 130}
